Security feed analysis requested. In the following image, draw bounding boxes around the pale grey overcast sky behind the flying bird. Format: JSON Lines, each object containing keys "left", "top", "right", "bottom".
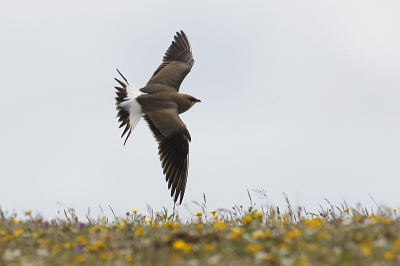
{"left": 0, "top": 1, "right": 400, "bottom": 218}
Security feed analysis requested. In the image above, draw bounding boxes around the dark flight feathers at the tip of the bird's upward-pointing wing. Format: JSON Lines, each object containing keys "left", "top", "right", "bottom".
{"left": 150, "top": 30, "right": 194, "bottom": 81}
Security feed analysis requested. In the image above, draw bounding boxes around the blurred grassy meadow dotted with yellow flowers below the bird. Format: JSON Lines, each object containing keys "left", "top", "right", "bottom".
{"left": 0, "top": 190, "right": 400, "bottom": 266}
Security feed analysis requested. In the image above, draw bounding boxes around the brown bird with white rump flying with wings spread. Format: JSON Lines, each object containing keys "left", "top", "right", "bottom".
{"left": 115, "top": 31, "right": 200, "bottom": 203}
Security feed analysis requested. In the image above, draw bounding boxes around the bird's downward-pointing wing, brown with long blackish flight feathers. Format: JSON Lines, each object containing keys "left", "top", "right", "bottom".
{"left": 143, "top": 109, "right": 191, "bottom": 203}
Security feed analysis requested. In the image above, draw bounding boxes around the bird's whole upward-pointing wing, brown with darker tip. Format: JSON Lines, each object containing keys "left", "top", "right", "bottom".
{"left": 140, "top": 31, "right": 194, "bottom": 93}
